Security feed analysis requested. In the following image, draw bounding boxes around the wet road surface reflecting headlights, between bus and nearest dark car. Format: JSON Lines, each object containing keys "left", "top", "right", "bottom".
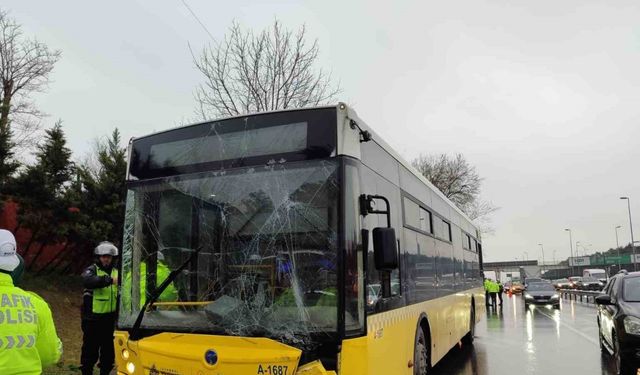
{"left": 433, "top": 295, "right": 613, "bottom": 375}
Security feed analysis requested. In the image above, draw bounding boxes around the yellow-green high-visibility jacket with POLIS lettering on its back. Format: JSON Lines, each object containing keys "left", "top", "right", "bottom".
{"left": 0, "top": 273, "right": 62, "bottom": 375}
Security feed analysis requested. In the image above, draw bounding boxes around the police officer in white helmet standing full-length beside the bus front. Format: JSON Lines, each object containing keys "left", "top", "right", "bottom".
{"left": 80, "top": 241, "right": 118, "bottom": 375}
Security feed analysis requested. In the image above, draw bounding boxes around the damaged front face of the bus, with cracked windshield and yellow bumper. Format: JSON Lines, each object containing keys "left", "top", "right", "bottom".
{"left": 115, "top": 107, "right": 356, "bottom": 375}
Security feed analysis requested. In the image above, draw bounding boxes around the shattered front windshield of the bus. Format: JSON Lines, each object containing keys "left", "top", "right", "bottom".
{"left": 119, "top": 160, "right": 342, "bottom": 347}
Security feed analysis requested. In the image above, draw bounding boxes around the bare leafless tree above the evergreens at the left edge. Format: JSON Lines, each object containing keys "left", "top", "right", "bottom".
{"left": 0, "top": 10, "right": 61, "bottom": 153}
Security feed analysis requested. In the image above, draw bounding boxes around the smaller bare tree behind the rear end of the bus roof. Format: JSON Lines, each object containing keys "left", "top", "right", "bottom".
{"left": 411, "top": 154, "right": 498, "bottom": 233}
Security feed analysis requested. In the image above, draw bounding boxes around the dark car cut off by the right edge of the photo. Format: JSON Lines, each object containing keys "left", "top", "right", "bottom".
{"left": 596, "top": 271, "right": 640, "bottom": 373}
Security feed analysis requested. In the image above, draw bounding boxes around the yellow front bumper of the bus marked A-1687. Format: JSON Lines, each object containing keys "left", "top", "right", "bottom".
{"left": 114, "top": 331, "right": 335, "bottom": 375}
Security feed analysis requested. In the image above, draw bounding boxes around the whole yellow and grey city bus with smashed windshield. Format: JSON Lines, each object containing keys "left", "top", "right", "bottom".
{"left": 115, "top": 103, "right": 485, "bottom": 375}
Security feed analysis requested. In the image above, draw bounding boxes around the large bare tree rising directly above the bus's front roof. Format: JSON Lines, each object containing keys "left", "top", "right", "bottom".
{"left": 192, "top": 20, "right": 340, "bottom": 119}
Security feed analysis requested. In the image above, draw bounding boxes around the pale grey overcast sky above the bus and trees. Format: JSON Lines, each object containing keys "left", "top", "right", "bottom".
{"left": 2, "top": 0, "right": 640, "bottom": 261}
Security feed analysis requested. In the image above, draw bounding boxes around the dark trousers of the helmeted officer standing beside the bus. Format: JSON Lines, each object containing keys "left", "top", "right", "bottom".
{"left": 80, "top": 318, "right": 115, "bottom": 375}
